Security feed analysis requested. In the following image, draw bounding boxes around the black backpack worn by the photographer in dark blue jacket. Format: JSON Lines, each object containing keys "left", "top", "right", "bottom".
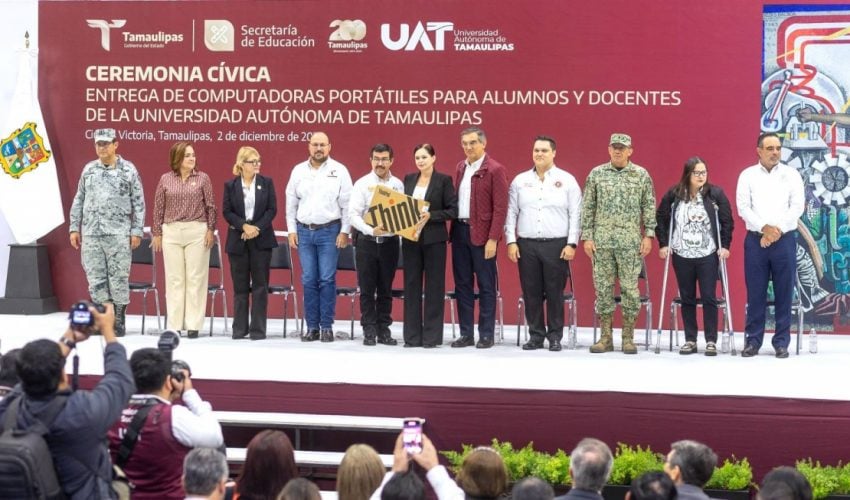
{"left": 0, "top": 395, "right": 68, "bottom": 500}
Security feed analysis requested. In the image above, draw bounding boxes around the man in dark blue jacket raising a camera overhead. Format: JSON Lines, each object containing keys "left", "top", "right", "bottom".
{"left": 0, "top": 304, "right": 135, "bottom": 500}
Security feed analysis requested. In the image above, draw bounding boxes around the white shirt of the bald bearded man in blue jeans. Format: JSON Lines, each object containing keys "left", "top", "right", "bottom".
{"left": 286, "top": 158, "right": 351, "bottom": 233}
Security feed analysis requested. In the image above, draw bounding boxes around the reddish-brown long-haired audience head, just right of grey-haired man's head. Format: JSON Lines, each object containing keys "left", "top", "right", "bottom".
{"left": 237, "top": 430, "right": 298, "bottom": 500}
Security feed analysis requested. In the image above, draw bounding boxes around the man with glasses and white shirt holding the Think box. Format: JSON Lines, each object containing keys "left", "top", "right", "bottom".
{"left": 348, "top": 144, "right": 404, "bottom": 346}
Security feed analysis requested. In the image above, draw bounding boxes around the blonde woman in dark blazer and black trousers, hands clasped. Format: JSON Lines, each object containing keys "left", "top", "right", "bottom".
{"left": 223, "top": 146, "right": 277, "bottom": 340}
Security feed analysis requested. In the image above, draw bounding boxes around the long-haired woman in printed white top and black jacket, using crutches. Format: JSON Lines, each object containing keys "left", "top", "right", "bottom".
{"left": 655, "top": 156, "right": 734, "bottom": 356}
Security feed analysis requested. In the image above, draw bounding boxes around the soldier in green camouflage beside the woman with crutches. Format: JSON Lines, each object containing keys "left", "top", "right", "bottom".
{"left": 581, "top": 134, "right": 655, "bottom": 354}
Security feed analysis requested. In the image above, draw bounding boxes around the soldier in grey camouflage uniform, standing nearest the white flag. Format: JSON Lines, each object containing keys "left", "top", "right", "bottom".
{"left": 69, "top": 128, "right": 145, "bottom": 336}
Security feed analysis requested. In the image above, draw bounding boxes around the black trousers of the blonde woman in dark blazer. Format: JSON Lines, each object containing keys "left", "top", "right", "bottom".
{"left": 227, "top": 240, "right": 272, "bottom": 339}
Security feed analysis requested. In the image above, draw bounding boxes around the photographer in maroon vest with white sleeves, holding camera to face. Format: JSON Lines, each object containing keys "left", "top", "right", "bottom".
{"left": 109, "top": 330, "right": 224, "bottom": 500}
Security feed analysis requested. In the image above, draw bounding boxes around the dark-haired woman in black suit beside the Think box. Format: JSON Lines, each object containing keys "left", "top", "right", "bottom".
{"left": 401, "top": 144, "right": 457, "bottom": 348}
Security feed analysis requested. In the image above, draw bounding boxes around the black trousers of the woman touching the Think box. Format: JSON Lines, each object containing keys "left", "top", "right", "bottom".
{"left": 401, "top": 240, "right": 446, "bottom": 346}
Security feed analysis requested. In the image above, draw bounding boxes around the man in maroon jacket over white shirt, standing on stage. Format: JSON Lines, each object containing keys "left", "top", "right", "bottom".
{"left": 452, "top": 127, "right": 508, "bottom": 349}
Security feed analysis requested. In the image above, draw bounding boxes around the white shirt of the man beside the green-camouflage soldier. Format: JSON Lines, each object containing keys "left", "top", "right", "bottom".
{"left": 505, "top": 165, "right": 581, "bottom": 244}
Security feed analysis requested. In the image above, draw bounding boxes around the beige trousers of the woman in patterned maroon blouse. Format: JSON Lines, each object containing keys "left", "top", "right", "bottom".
{"left": 162, "top": 222, "right": 210, "bottom": 331}
